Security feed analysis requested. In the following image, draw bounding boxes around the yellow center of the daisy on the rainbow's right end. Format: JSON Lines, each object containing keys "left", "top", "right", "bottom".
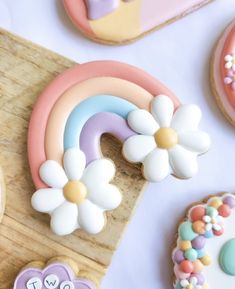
{"left": 154, "top": 127, "right": 178, "bottom": 149}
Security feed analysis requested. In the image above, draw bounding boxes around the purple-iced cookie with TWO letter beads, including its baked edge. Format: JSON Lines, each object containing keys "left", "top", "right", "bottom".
{"left": 14, "top": 257, "right": 97, "bottom": 289}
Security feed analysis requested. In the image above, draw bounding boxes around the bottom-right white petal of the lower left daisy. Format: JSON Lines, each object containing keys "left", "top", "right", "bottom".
{"left": 78, "top": 200, "right": 105, "bottom": 234}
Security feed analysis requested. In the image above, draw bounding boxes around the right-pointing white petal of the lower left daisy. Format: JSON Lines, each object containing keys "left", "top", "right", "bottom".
{"left": 87, "top": 184, "right": 122, "bottom": 210}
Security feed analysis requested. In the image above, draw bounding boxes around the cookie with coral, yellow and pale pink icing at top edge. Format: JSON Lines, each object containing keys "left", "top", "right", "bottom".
{"left": 64, "top": 0, "right": 211, "bottom": 44}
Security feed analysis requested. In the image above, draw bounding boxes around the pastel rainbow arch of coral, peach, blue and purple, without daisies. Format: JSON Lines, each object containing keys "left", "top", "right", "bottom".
{"left": 28, "top": 61, "right": 179, "bottom": 189}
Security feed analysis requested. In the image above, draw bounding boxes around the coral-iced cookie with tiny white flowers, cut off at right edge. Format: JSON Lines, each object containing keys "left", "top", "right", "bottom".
{"left": 211, "top": 20, "right": 235, "bottom": 125}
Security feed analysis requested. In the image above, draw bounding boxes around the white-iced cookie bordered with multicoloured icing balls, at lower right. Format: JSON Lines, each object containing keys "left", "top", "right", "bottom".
{"left": 172, "top": 194, "right": 235, "bottom": 289}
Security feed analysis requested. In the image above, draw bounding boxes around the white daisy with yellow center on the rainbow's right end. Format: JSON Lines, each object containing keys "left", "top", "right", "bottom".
{"left": 123, "top": 95, "right": 210, "bottom": 182}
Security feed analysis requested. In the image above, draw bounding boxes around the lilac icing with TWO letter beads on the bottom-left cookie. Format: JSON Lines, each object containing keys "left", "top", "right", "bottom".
{"left": 14, "top": 262, "right": 96, "bottom": 289}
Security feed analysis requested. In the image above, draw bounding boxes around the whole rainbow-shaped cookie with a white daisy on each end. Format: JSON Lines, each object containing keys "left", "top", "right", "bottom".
{"left": 28, "top": 61, "right": 210, "bottom": 235}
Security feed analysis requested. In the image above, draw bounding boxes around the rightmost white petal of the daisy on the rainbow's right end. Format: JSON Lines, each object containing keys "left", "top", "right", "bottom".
{"left": 178, "top": 131, "right": 211, "bottom": 154}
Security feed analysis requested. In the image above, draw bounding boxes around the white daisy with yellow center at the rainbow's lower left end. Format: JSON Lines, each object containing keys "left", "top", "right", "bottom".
{"left": 32, "top": 148, "right": 122, "bottom": 235}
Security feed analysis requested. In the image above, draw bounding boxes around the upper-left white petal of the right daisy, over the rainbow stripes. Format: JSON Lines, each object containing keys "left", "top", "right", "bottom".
{"left": 128, "top": 109, "right": 159, "bottom": 135}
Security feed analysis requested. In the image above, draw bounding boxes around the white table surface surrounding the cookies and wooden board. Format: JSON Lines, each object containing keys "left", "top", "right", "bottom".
{"left": 0, "top": 0, "right": 235, "bottom": 289}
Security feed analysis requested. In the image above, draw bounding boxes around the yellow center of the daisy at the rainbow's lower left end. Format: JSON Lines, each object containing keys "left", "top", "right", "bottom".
{"left": 63, "top": 181, "right": 87, "bottom": 204}
